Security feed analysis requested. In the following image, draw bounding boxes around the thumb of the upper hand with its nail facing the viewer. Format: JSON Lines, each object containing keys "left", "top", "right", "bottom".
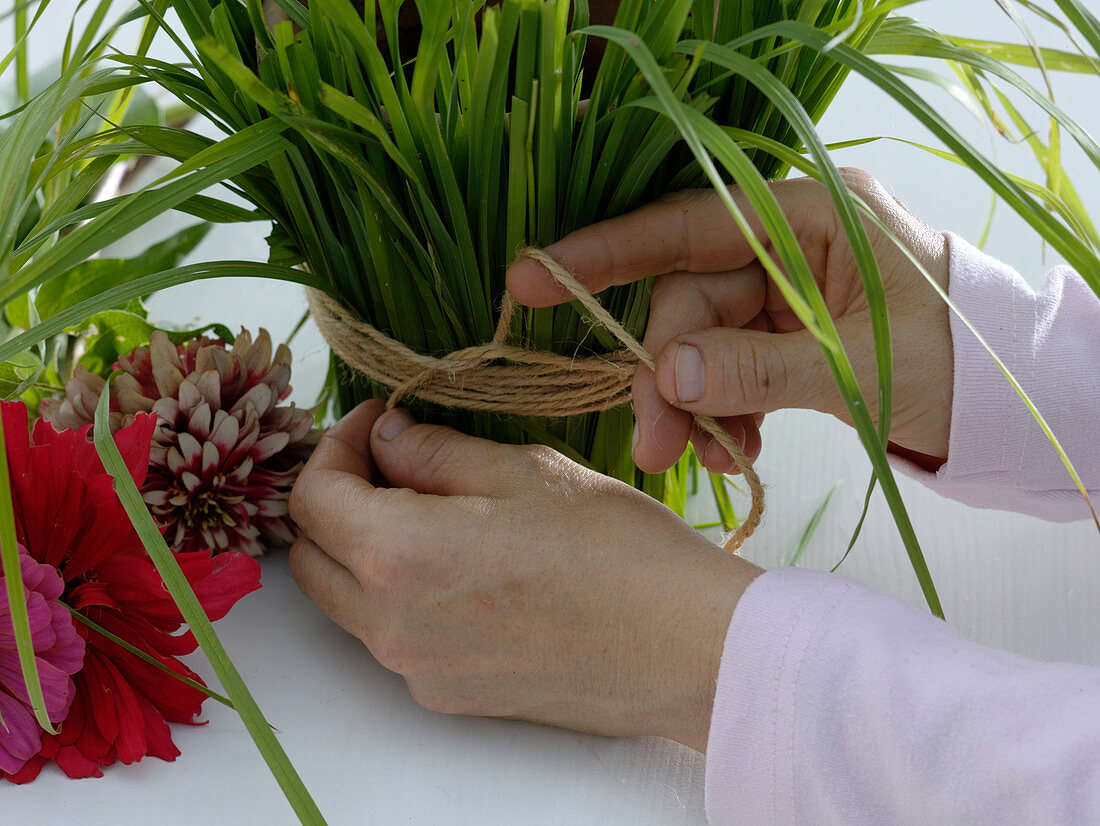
{"left": 657, "top": 327, "right": 838, "bottom": 417}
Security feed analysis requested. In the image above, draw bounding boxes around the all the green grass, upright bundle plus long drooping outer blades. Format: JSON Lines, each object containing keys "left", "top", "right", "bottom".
{"left": 0, "top": 0, "right": 1100, "bottom": 823}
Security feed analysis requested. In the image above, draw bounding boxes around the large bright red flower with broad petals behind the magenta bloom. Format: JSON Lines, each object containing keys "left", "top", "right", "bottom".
{"left": 0, "top": 403, "right": 260, "bottom": 782}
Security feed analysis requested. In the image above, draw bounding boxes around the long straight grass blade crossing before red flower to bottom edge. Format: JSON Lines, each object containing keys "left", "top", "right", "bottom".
{"left": 92, "top": 383, "right": 325, "bottom": 826}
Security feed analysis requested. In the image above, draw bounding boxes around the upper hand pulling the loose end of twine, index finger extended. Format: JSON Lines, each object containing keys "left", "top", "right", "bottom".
{"left": 507, "top": 169, "right": 954, "bottom": 473}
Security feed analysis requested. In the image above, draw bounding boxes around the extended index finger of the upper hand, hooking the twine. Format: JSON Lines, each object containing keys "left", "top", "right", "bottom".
{"left": 507, "top": 189, "right": 760, "bottom": 307}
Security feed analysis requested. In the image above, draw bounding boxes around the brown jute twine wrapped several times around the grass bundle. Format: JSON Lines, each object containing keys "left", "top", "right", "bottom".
{"left": 307, "top": 247, "right": 765, "bottom": 552}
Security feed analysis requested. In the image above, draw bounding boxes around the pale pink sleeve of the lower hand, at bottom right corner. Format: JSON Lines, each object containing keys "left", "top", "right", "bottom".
{"left": 706, "top": 569, "right": 1100, "bottom": 826}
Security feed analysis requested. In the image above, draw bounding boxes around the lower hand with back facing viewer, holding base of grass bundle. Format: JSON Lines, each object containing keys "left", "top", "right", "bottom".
{"left": 290, "top": 401, "right": 760, "bottom": 750}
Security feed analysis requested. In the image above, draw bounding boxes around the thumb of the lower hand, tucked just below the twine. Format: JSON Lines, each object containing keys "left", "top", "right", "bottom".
{"left": 371, "top": 408, "right": 508, "bottom": 496}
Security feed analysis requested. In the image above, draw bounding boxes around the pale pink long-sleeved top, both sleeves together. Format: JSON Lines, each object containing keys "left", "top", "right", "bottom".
{"left": 706, "top": 235, "right": 1100, "bottom": 826}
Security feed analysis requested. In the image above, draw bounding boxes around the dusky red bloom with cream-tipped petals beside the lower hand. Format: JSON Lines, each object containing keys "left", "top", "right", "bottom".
{"left": 40, "top": 330, "right": 317, "bottom": 557}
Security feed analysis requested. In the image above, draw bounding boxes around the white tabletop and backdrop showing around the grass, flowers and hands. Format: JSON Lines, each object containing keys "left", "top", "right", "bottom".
{"left": 0, "top": 0, "right": 1100, "bottom": 824}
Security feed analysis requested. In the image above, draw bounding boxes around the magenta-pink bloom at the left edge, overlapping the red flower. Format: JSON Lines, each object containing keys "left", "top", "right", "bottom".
{"left": 0, "top": 547, "right": 84, "bottom": 774}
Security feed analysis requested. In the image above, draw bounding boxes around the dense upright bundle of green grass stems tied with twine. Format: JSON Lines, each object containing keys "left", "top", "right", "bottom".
{"left": 143, "top": 0, "right": 883, "bottom": 522}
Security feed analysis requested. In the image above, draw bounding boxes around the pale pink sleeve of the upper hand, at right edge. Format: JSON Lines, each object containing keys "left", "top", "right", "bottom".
{"left": 893, "top": 233, "right": 1100, "bottom": 521}
